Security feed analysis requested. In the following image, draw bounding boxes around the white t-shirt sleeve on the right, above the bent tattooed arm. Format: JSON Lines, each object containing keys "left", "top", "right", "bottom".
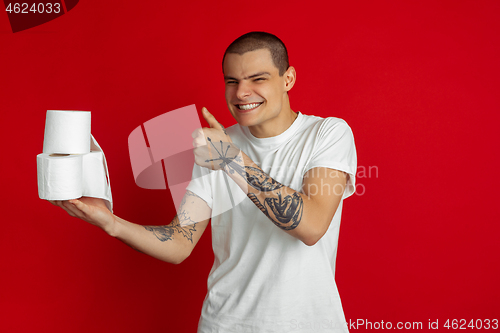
{"left": 304, "top": 118, "right": 357, "bottom": 199}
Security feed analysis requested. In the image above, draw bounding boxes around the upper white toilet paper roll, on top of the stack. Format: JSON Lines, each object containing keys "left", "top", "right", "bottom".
{"left": 43, "top": 110, "right": 90, "bottom": 154}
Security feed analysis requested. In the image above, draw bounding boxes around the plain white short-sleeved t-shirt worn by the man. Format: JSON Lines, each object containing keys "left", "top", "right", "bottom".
{"left": 188, "top": 113, "right": 356, "bottom": 333}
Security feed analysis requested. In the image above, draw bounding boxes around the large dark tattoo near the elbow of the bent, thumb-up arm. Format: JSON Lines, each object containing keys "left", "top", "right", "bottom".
{"left": 247, "top": 192, "right": 304, "bottom": 230}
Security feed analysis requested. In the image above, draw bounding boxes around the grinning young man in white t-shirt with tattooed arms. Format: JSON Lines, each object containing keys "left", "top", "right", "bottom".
{"left": 54, "top": 32, "right": 356, "bottom": 333}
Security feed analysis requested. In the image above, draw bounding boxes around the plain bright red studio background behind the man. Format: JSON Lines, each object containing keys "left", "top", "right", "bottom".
{"left": 0, "top": 0, "right": 500, "bottom": 332}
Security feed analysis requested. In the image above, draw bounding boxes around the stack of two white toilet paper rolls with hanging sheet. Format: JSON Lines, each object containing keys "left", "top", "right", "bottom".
{"left": 36, "top": 110, "right": 113, "bottom": 211}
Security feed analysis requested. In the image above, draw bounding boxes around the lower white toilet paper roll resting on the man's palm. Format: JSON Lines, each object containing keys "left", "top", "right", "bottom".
{"left": 36, "top": 154, "right": 83, "bottom": 200}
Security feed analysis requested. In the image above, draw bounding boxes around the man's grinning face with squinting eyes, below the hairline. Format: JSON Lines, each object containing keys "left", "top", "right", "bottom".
{"left": 223, "top": 49, "right": 289, "bottom": 126}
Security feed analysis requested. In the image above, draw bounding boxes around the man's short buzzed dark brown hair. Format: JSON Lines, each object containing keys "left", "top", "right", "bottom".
{"left": 222, "top": 31, "right": 289, "bottom": 76}
